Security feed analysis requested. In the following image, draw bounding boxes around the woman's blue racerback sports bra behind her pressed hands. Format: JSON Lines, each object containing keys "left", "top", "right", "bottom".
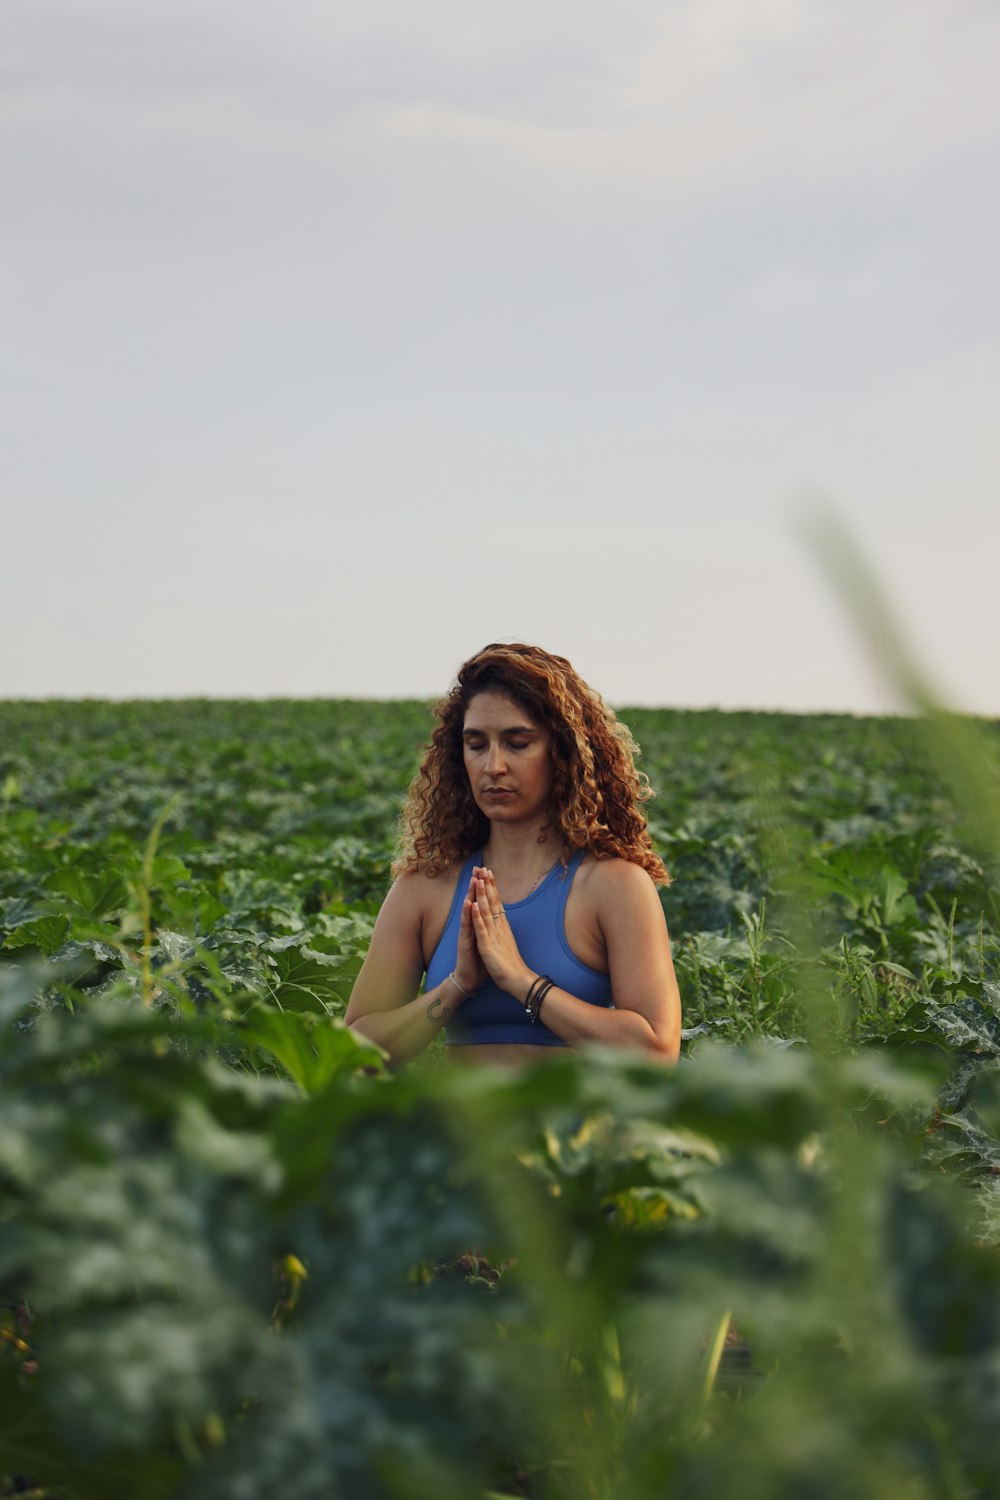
{"left": 424, "top": 851, "right": 613, "bottom": 1047}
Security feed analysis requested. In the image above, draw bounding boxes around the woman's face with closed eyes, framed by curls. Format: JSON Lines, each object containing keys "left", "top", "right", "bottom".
{"left": 462, "top": 693, "right": 553, "bottom": 824}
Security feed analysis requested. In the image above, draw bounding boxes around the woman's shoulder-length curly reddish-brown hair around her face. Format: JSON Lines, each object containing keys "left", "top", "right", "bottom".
{"left": 393, "top": 645, "right": 669, "bottom": 885}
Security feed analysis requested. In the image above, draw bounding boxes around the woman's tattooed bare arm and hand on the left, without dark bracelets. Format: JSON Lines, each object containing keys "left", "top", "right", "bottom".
{"left": 345, "top": 875, "right": 483, "bottom": 1068}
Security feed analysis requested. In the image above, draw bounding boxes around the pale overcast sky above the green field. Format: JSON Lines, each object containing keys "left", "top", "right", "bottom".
{"left": 0, "top": 0, "right": 1000, "bottom": 714}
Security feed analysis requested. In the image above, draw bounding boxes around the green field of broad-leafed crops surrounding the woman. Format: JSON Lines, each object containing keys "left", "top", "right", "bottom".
{"left": 0, "top": 701, "right": 1000, "bottom": 1500}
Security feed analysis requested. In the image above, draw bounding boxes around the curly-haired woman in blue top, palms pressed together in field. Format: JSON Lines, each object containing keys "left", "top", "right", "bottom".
{"left": 346, "top": 645, "right": 681, "bottom": 1067}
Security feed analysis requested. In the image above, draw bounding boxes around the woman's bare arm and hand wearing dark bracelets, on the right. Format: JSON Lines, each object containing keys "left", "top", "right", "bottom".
{"left": 474, "top": 860, "right": 681, "bottom": 1064}
